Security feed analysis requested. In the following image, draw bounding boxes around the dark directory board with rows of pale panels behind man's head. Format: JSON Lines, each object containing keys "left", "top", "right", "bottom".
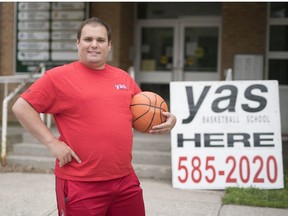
{"left": 15, "top": 2, "right": 89, "bottom": 73}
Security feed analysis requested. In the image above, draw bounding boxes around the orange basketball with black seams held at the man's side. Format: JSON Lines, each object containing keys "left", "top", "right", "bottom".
{"left": 131, "top": 91, "right": 168, "bottom": 133}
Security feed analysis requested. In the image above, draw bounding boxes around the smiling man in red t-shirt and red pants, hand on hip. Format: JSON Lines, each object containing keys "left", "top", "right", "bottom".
{"left": 13, "top": 18, "right": 176, "bottom": 216}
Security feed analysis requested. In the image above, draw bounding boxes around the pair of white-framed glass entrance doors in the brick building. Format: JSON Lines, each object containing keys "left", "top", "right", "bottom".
{"left": 135, "top": 17, "right": 221, "bottom": 102}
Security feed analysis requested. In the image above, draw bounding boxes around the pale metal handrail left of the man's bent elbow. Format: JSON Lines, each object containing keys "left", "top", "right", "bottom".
{"left": 0, "top": 63, "right": 45, "bottom": 165}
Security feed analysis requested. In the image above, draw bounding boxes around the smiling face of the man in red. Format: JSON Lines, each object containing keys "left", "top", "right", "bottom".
{"left": 77, "top": 24, "right": 111, "bottom": 69}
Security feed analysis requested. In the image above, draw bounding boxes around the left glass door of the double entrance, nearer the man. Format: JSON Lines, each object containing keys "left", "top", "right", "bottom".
{"left": 135, "top": 20, "right": 177, "bottom": 84}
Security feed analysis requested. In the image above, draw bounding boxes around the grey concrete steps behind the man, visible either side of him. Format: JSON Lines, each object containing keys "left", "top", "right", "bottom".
{"left": 7, "top": 131, "right": 172, "bottom": 179}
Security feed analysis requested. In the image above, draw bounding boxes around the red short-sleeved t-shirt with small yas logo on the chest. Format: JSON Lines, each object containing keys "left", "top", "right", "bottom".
{"left": 21, "top": 62, "right": 141, "bottom": 181}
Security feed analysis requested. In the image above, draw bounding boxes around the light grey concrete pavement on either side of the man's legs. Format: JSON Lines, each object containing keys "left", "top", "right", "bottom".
{"left": 0, "top": 172, "right": 288, "bottom": 216}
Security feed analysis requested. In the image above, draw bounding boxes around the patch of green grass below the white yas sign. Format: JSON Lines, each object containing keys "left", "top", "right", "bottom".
{"left": 222, "top": 169, "right": 288, "bottom": 208}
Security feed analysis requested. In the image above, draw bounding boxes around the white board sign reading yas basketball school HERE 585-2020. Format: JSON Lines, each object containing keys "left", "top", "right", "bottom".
{"left": 170, "top": 80, "right": 284, "bottom": 189}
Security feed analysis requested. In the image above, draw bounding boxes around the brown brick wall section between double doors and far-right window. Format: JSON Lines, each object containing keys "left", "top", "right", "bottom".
{"left": 221, "top": 3, "right": 267, "bottom": 79}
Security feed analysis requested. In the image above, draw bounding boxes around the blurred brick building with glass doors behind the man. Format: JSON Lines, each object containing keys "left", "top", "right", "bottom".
{"left": 0, "top": 2, "right": 288, "bottom": 134}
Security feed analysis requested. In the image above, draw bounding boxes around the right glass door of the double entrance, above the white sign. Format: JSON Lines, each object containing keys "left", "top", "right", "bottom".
{"left": 176, "top": 17, "right": 221, "bottom": 81}
